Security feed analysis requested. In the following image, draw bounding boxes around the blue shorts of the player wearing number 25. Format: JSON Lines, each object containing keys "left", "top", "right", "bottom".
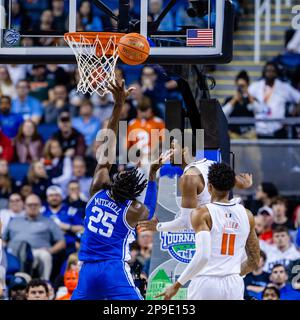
{"left": 71, "top": 260, "right": 143, "bottom": 300}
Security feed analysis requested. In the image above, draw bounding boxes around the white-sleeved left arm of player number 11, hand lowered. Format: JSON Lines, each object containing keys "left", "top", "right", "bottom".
{"left": 157, "top": 207, "right": 212, "bottom": 300}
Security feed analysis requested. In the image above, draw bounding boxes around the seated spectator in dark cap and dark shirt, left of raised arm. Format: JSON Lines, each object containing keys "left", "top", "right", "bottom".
{"left": 53, "top": 111, "right": 86, "bottom": 157}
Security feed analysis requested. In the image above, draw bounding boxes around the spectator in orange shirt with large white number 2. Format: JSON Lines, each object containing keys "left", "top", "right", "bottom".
{"left": 127, "top": 97, "right": 165, "bottom": 159}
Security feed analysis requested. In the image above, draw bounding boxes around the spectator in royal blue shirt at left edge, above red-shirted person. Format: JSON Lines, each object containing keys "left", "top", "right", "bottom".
{"left": 0, "top": 96, "right": 23, "bottom": 139}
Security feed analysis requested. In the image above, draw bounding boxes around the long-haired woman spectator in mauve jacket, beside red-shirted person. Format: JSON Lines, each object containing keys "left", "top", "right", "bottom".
{"left": 14, "top": 120, "right": 43, "bottom": 163}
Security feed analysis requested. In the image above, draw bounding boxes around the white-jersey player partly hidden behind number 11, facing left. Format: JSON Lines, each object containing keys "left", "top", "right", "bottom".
{"left": 139, "top": 140, "right": 252, "bottom": 232}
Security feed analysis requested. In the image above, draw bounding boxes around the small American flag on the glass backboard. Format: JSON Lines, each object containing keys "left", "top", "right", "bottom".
{"left": 186, "top": 29, "right": 214, "bottom": 47}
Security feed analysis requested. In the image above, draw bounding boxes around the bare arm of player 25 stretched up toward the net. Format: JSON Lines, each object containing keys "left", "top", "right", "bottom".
{"left": 90, "top": 80, "right": 134, "bottom": 196}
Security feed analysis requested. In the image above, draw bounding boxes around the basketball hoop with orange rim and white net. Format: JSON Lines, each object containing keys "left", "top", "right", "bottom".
{"left": 64, "top": 32, "right": 125, "bottom": 96}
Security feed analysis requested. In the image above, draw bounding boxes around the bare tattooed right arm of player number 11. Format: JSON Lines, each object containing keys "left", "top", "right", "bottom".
{"left": 241, "top": 210, "right": 260, "bottom": 276}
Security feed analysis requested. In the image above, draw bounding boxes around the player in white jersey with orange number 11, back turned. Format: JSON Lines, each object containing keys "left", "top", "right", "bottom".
{"left": 159, "top": 163, "right": 260, "bottom": 300}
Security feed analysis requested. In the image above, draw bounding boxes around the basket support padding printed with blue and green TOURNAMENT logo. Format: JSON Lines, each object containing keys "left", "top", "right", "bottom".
{"left": 146, "top": 150, "right": 220, "bottom": 300}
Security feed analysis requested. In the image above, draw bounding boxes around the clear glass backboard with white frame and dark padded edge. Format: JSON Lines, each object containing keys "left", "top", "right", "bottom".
{"left": 0, "top": 0, "right": 233, "bottom": 64}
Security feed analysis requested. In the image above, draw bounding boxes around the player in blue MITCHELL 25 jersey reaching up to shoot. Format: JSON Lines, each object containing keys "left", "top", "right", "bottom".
{"left": 72, "top": 81, "right": 169, "bottom": 300}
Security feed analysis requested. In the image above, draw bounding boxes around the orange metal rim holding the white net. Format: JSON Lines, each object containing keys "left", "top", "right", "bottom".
{"left": 64, "top": 32, "right": 126, "bottom": 55}
